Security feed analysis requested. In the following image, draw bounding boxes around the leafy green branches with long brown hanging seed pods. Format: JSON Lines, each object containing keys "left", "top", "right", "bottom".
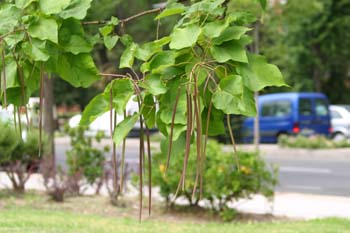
{"left": 0, "top": 0, "right": 285, "bottom": 221}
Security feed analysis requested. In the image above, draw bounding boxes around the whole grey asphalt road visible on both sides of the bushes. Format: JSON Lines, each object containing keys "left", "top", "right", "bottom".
{"left": 56, "top": 139, "right": 350, "bottom": 196}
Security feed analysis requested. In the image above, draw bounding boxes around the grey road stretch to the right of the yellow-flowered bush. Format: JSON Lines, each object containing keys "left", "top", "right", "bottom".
{"left": 266, "top": 154, "right": 350, "bottom": 197}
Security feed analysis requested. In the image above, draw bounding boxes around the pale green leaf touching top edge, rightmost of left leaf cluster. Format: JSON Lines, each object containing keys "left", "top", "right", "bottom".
{"left": 60, "top": 0, "right": 92, "bottom": 20}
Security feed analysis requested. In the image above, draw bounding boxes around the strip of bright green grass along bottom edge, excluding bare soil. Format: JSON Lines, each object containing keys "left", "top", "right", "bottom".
{"left": 0, "top": 207, "right": 350, "bottom": 233}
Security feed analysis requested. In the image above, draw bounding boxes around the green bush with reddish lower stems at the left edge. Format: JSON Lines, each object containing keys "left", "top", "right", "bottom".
{"left": 0, "top": 122, "right": 47, "bottom": 192}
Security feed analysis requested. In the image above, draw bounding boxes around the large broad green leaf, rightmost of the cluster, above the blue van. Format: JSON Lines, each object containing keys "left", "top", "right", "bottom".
{"left": 238, "top": 54, "right": 287, "bottom": 91}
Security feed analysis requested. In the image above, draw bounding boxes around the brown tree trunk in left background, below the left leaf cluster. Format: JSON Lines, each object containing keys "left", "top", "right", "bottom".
{"left": 43, "top": 76, "right": 55, "bottom": 166}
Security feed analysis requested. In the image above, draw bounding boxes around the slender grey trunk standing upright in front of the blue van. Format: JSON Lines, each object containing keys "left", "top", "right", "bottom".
{"left": 253, "top": 22, "right": 260, "bottom": 152}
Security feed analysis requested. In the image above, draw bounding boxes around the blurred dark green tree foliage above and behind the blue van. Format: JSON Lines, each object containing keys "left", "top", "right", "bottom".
{"left": 261, "top": 0, "right": 350, "bottom": 104}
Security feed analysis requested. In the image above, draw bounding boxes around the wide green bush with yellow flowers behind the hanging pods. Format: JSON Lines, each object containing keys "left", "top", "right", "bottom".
{"left": 138, "top": 141, "right": 277, "bottom": 219}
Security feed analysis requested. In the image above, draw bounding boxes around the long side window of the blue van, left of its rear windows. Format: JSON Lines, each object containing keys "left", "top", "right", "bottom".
{"left": 261, "top": 100, "right": 291, "bottom": 117}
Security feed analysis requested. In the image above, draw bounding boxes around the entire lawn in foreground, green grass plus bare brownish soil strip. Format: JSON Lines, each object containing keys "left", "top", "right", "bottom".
{"left": 0, "top": 192, "right": 350, "bottom": 233}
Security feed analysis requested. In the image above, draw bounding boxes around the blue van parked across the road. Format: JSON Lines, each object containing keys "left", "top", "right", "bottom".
{"left": 243, "top": 93, "right": 332, "bottom": 143}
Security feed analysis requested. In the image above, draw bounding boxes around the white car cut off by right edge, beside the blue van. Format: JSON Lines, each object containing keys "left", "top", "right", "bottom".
{"left": 329, "top": 105, "right": 350, "bottom": 141}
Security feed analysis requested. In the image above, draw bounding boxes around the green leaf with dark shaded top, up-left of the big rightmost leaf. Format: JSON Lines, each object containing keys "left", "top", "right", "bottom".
{"left": 210, "top": 40, "right": 248, "bottom": 63}
